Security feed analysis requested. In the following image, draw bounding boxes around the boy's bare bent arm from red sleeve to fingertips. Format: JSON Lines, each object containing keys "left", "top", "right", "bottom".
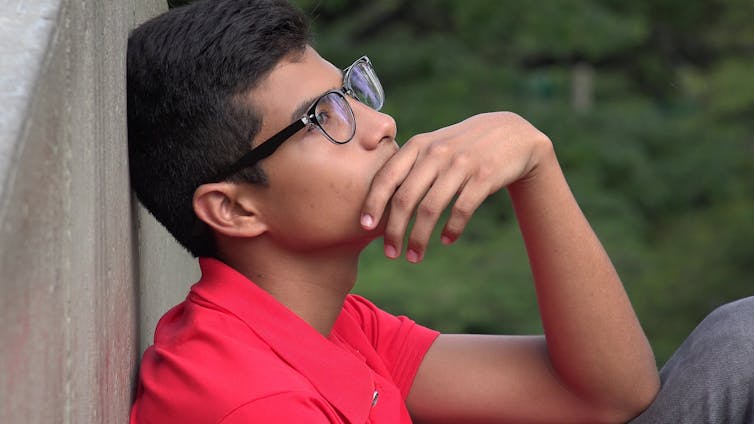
{"left": 361, "top": 112, "right": 658, "bottom": 422}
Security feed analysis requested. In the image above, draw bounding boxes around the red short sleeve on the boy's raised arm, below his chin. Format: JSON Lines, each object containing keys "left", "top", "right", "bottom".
{"left": 343, "top": 294, "right": 440, "bottom": 399}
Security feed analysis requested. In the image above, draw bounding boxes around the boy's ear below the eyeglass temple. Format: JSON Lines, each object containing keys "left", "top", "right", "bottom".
{"left": 193, "top": 183, "right": 267, "bottom": 238}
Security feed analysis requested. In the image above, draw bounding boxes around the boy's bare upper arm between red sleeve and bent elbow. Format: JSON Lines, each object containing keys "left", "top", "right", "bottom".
{"left": 407, "top": 334, "right": 620, "bottom": 423}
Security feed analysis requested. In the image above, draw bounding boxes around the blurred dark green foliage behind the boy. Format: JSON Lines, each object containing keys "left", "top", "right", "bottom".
{"left": 176, "top": 0, "right": 754, "bottom": 363}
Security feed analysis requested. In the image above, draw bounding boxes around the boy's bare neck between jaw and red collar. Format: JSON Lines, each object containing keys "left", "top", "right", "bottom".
{"left": 217, "top": 238, "right": 361, "bottom": 337}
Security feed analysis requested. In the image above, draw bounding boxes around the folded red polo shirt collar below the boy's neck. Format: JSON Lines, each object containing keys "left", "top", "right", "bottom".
{"left": 191, "top": 258, "right": 374, "bottom": 422}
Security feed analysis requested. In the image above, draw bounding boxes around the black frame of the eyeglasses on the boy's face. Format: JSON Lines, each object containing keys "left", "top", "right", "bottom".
{"left": 212, "top": 56, "right": 378, "bottom": 182}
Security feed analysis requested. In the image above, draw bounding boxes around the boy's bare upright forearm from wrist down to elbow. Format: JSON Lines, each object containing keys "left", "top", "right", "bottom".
{"left": 509, "top": 143, "right": 659, "bottom": 414}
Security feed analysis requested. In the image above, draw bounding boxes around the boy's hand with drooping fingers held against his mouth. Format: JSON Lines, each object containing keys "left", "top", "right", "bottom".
{"left": 361, "top": 112, "right": 552, "bottom": 263}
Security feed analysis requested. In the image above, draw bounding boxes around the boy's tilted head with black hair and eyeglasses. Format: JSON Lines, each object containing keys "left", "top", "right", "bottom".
{"left": 127, "top": 0, "right": 397, "bottom": 256}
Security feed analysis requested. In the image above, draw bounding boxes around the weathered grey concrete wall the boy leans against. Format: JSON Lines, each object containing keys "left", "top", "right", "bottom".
{"left": 0, "top": 0, "right": 197, "bottom": 423}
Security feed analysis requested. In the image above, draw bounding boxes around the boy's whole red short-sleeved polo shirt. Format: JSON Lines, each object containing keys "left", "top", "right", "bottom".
{"left": 131, "top": 258, "right": 438, "bottom": 424}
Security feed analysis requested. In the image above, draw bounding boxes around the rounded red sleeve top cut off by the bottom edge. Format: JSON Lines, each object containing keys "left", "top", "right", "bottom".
{"left": 218, "top": 392, "right": 343, "bottom": 424}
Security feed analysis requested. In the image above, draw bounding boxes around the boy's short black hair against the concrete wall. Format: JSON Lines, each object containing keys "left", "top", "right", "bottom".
{"left": 126, "top": 0, "right": 309, "bottom": 256}
